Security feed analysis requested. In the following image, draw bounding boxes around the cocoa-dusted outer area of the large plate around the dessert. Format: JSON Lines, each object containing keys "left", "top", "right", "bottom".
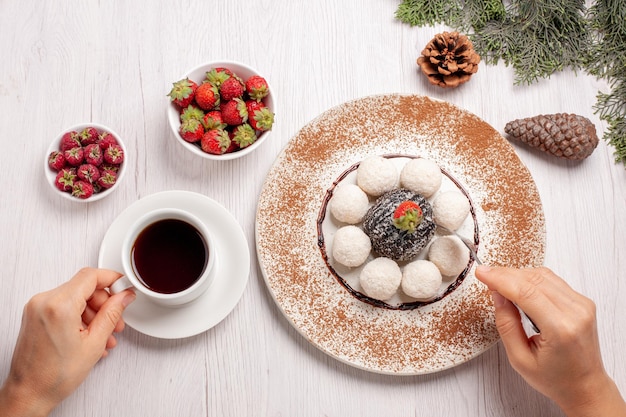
{"left": 256, "top": 95, "right": 545, "bottom": 375}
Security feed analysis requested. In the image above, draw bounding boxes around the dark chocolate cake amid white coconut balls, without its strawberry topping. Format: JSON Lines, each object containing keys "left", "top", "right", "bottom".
{"left": 363, "top": 188, "right": 435, "bottom": 261}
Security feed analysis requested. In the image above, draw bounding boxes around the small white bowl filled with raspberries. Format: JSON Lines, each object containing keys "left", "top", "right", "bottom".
{"left": 44, "top": 123, "right": 126, "bottom": 202}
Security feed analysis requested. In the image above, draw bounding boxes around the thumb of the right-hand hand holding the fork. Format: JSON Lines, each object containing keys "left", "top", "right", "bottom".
{"left": 491, "top": 291, "right": 531, "bottom": 369}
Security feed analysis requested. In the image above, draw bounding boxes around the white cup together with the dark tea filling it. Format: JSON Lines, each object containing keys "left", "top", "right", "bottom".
{"left": 110, "top": 208, "right": 216, "bottom": 307}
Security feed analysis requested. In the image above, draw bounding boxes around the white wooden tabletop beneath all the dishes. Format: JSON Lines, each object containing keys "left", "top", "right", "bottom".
{"left": 0, "top": 0, "right": 626, "bottom": 417}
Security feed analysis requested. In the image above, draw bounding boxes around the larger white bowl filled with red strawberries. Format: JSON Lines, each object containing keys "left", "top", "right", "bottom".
{"left": 168, "top": 61, "right": 274, "bottom": 160}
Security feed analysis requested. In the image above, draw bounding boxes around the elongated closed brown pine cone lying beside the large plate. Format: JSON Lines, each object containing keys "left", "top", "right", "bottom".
{"left": 504, "top": 113, "right": 598, "bottom": 160}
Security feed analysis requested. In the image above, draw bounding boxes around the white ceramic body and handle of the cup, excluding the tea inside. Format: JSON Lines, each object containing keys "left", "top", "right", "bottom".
{"left": 110, "top": 208, "right": 217, "bottom": 307}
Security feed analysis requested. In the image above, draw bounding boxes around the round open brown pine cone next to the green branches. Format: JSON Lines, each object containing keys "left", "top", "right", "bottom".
{"left": 417, "top": 32, "right": 480, "bottom": 87}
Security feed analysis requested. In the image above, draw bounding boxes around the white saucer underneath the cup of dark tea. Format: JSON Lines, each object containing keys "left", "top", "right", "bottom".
{"left": 98, "top": 191, "right": 250, "bottom": 339}
